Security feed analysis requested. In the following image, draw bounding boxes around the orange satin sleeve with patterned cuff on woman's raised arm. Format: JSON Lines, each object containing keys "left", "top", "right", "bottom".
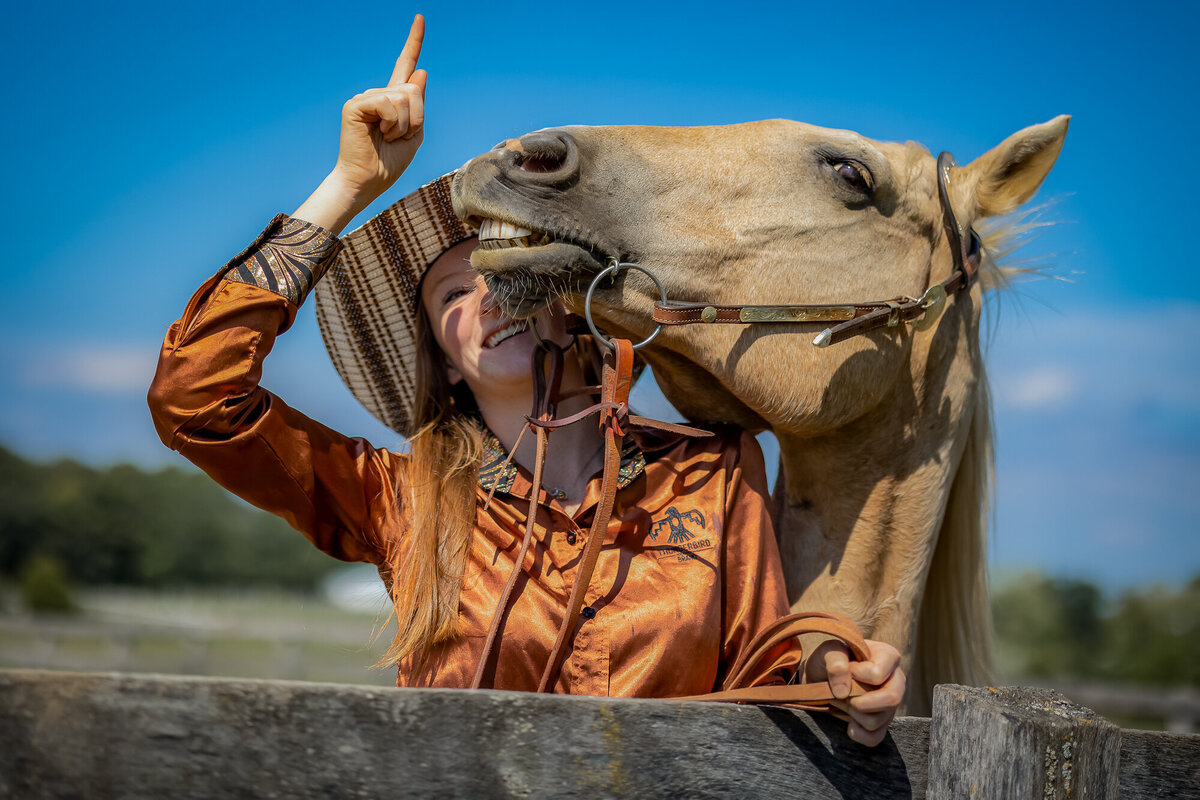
{"left": 148, "top": 215, "right": 404, "bottom": 564}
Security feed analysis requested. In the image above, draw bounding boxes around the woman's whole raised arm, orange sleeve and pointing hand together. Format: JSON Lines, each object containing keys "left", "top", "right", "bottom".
{"left": 148, "top": 16, "right": 425, "bottom": 563}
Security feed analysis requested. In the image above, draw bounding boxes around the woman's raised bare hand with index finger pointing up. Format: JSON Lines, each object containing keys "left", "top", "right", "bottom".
{"left": 292, "top": 14, "right": 428, "bottom": 234}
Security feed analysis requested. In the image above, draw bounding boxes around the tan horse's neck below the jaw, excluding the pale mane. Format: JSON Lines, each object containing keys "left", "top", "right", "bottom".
{"left": 776, "top": 320, "right": 982, "bottom": 652}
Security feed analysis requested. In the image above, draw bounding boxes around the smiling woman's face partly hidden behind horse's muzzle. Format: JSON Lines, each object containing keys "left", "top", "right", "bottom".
{"left": 421, "top": 239, "right": 570, "bottom": 404}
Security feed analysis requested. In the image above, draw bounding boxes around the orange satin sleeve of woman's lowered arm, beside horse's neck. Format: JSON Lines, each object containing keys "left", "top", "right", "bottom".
{"left": 716, "top": 432, "right": 802, "bottom": 688}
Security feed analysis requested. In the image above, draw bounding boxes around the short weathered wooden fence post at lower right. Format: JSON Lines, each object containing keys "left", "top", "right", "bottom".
{"left": 929, "top": 685, "right": 1121, "bottom": 800}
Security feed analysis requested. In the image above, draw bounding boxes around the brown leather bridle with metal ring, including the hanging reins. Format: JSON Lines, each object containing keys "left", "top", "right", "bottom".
{"left": 472, "top": 152, "right": 980, "bottom": 709}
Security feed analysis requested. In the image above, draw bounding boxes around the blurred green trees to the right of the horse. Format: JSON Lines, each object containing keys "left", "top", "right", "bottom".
{"left": 991, "top": 573, "right": 1200, "bottom": 686}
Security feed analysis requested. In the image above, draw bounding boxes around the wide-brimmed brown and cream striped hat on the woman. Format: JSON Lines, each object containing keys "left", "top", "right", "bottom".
{"left": 314, "top": 173, "right": 478, "bottom": 437}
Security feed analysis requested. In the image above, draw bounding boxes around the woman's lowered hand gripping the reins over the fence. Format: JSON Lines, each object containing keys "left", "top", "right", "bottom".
{"left": 804, "top": 639, "right": 905, "bottom": 747}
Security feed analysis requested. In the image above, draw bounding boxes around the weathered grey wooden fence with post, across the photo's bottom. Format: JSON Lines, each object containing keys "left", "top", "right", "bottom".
{"left": 0, "top": 670, "right": 1200, "bottom": 800}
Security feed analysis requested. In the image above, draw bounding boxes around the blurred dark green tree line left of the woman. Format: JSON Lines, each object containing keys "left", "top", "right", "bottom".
{"left": 0, "top": 447, "right": 336, "bottom": 590}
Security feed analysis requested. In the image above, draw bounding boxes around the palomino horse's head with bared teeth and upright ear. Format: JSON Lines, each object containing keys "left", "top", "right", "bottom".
{"left": 454, "top": 118, "right": 1067, "bottom": 434}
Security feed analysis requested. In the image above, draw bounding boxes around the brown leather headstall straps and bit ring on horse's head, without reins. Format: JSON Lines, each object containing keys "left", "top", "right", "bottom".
{"left": 633, "top": 151, "right": 982, "bottom": 347}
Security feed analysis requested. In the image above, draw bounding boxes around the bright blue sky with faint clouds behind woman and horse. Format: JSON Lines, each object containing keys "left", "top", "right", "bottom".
{"left": 0, "top": 2, "right": 1200, "bottom": 587}
